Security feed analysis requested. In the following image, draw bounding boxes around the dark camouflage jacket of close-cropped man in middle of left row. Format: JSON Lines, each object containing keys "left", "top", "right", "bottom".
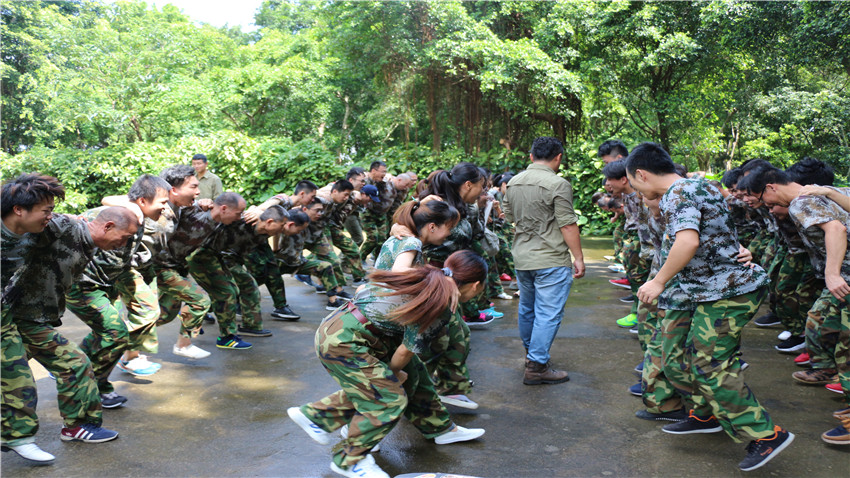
{"left": 154, "top": 203, "right": 221, "bottom": 270}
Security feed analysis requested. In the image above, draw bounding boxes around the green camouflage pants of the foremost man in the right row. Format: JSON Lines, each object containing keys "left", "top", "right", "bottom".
{"left": 664, "top": 289, "right": 774, "bottom": 441}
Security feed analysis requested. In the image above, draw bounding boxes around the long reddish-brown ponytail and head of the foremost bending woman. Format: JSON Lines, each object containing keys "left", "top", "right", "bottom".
{"left": 369, "top": 250, "right": 487, "bottom": 329}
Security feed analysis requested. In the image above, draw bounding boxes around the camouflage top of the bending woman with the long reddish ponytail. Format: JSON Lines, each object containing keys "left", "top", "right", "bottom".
{"left": 352, "top": 283, "right": 452, "bottom": 354}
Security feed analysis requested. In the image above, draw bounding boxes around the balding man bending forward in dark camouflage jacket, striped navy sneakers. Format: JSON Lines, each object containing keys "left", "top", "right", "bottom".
{"left": 4, "top": 197, "right": 139, "bottom": 442}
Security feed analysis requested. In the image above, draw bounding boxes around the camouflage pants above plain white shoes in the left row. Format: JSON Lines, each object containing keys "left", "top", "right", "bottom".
{"left": 156, "top": 269, "right": 210, "bottom": 339}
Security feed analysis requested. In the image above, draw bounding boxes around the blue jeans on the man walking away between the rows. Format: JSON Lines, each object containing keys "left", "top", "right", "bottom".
{"left": 516, "top": 267, "right": 573, "bottom": 364}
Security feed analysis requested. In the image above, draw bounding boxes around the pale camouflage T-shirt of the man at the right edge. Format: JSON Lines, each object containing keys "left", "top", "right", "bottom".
{"left": 788, "top": 188, "right": 850, "bottom": 282}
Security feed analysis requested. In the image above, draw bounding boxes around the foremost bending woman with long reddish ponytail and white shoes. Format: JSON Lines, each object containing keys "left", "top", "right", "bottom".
{"left": 287, "top": 251, "right": 487, "bottom": 478}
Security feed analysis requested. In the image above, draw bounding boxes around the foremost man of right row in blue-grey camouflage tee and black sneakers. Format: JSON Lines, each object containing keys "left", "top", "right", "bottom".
{"left": 626, "top": 143, "right": 794, "bottom": 471}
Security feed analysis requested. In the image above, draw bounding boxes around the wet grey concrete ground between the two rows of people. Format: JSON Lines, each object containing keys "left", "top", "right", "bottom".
{"left": 2, "top": 238, "right": 850, "bottom": 478}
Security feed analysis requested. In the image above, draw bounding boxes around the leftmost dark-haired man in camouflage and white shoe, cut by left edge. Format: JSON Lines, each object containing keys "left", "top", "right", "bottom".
{"left": 0, "top": 174, "right": 65, "bottom": 463}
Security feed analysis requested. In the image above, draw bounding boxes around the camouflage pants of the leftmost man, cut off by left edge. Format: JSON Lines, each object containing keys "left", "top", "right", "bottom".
{"left": 0, "top": 311, "right": 38, "bottom": 446}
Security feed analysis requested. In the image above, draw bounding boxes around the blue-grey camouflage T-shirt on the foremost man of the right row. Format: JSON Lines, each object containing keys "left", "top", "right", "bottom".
{"left": 658, "top": 178, "right": 768, "bottom": 310}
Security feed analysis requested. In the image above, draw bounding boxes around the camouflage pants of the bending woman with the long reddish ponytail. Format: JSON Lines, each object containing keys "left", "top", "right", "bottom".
{"left": 301, "top": 312, "right": 454, "bottom": 467}
